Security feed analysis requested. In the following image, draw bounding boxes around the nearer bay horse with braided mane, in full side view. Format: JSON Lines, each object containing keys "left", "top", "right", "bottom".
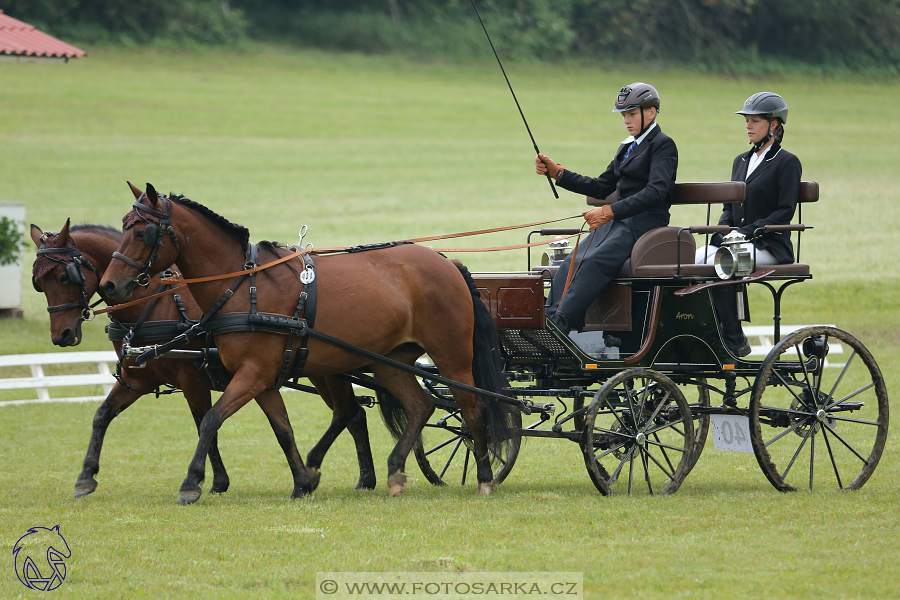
{"left": 101, "top": 184, "right": 510, "bottom": 503}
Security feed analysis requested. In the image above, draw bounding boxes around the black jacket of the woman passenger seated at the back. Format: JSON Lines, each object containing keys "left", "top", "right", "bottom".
{"left": 712, "top": 143, "right": 803, "bottom": 264}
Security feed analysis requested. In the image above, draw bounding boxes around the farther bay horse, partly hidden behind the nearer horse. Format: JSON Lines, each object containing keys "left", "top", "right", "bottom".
{"left": 31, "top": 218, "right": 376, "bottom": 498}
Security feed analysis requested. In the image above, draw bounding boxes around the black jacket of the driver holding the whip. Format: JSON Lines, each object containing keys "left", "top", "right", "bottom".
{"left": 559, "top": 125, "right": 678, "bottom": 239}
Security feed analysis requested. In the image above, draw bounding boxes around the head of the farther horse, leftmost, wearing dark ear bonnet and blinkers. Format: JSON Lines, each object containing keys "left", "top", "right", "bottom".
{"left": 31, "top": 219, "right": 100, "bottom": 346}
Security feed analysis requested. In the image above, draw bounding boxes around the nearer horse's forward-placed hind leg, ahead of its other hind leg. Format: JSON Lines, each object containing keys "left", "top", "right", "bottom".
{"left": 372, "top": 365, "right": 434, "bottom": 496}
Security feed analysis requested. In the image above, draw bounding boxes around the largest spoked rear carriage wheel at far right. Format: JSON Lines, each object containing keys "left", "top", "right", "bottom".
{"left": 750, "top": 326, "right": 888, "bottom": 492}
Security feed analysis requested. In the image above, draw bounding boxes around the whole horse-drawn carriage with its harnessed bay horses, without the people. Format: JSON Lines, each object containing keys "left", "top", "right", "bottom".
{"left": 35, "top": 182, "right": 888, "bottom": 502}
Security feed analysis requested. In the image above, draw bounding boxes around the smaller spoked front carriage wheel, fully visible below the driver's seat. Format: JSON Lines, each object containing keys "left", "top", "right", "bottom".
{"left": 582, "top": 369, "right": 695, "bottom": 496}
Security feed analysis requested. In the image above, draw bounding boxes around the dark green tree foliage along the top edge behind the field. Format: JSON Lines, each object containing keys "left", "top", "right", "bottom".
{"left": 0, "top": 0, "right": 900, "bottom": 71}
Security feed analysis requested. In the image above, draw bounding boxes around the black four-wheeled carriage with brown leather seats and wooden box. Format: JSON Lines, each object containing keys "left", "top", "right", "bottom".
{"left": 416, "top": 182, "right": 888, "bottom": 495}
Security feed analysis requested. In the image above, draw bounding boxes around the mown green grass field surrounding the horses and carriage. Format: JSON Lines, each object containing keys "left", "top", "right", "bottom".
{"left": 0, "top": 47, "right": 900, "bottom": 598}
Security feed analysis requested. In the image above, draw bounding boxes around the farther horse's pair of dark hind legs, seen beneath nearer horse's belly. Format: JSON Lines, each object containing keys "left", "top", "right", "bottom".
{"left": 306, "top": 377, "right": 376, "bottom": 490}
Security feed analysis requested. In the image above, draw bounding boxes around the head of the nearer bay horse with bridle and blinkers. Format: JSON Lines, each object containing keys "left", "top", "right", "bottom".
{"left": 100, "top": 182, "right": 179, "bottom": 301}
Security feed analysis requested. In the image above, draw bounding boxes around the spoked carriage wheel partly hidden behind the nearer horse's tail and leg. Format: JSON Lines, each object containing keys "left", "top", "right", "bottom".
{"left": 413, "top": 409, "right": 522, "bottom": 485}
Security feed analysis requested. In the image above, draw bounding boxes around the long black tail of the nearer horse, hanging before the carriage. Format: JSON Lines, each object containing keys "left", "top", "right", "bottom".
{"left": 453, "top": 260, "right": 514, "bottom": 457}
